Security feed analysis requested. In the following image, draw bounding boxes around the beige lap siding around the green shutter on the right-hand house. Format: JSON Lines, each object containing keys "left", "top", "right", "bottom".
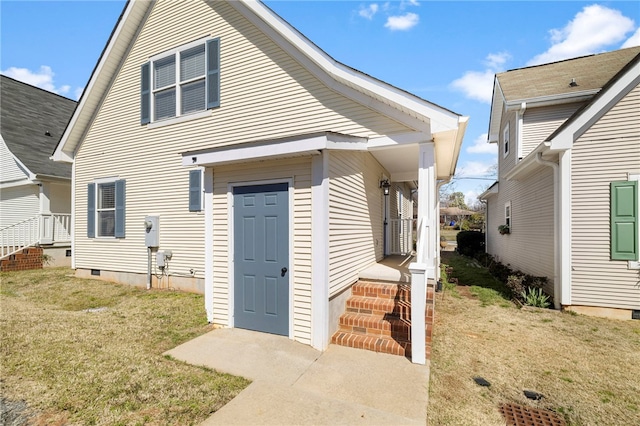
{"left": 571, "top": 83, "right": 640, "bottom": 309}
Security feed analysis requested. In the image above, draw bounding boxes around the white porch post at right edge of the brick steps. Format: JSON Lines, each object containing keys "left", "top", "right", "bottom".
{"left": 409, "top": 142, "right": 437, "bottom": 364}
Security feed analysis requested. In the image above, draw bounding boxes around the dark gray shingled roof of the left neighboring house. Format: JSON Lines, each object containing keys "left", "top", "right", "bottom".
{"left": 0, "top": 75, "right": 76, "bottom": 178}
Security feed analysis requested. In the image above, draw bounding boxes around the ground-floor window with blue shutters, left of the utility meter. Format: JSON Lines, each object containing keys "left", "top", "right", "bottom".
{"left": 87, "top": 180, "right": 125, "bottom": 238}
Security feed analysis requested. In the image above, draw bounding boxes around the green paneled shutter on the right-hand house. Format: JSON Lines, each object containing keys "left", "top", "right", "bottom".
{"left": 611, "top": 181, "right": 638, "bottom": 260}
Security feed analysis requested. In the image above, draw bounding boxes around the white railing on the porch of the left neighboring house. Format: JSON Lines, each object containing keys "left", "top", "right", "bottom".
{"left": 0, "top": 213, "right": 71, "bottom": 258}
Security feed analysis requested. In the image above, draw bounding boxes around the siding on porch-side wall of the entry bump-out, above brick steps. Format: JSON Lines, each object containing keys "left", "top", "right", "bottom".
{"left": 329, "top": 151, "right": 385, "bottom": 297}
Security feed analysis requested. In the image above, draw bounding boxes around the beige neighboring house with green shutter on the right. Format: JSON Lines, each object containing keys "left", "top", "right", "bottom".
{"left": 480, "top": 47, "right": 640, "bottom": 319}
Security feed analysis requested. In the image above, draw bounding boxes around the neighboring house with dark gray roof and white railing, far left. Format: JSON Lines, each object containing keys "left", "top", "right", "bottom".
{"left": 0, "top": 75, "right": 76, "bottom": 269}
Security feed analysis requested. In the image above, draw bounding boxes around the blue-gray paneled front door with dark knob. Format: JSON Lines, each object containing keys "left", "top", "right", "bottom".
{"left": 233, "top": 183, "right": 289, "bottom": 336}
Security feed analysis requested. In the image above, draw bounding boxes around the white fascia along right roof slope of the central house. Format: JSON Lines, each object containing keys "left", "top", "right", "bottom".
{"left": 229, "top": 0, "right": 459, "bottom": 132}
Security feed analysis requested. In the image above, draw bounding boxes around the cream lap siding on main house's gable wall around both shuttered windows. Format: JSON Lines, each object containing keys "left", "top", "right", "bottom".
{"left": 74, "top": 1, "right": 409, "bottom": 278}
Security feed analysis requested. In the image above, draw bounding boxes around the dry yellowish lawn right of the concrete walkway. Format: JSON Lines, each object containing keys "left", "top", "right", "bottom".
{"left": 428, "top": 252, "right": 640, "bottom": 426}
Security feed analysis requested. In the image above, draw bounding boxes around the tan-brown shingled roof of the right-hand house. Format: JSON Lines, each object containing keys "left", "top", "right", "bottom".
{"left": 497, "top": 47, "right": 640, "bottom": 102}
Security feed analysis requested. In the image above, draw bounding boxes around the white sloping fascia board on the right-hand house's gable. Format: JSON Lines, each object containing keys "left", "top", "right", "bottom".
{"left": 551, "top": 61, "right": 640, "bottom": 151}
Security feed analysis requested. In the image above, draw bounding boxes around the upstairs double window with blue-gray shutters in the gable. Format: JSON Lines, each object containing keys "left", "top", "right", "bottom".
{"left": 141, "top": 39, "right": 220, "bottom": 124}
